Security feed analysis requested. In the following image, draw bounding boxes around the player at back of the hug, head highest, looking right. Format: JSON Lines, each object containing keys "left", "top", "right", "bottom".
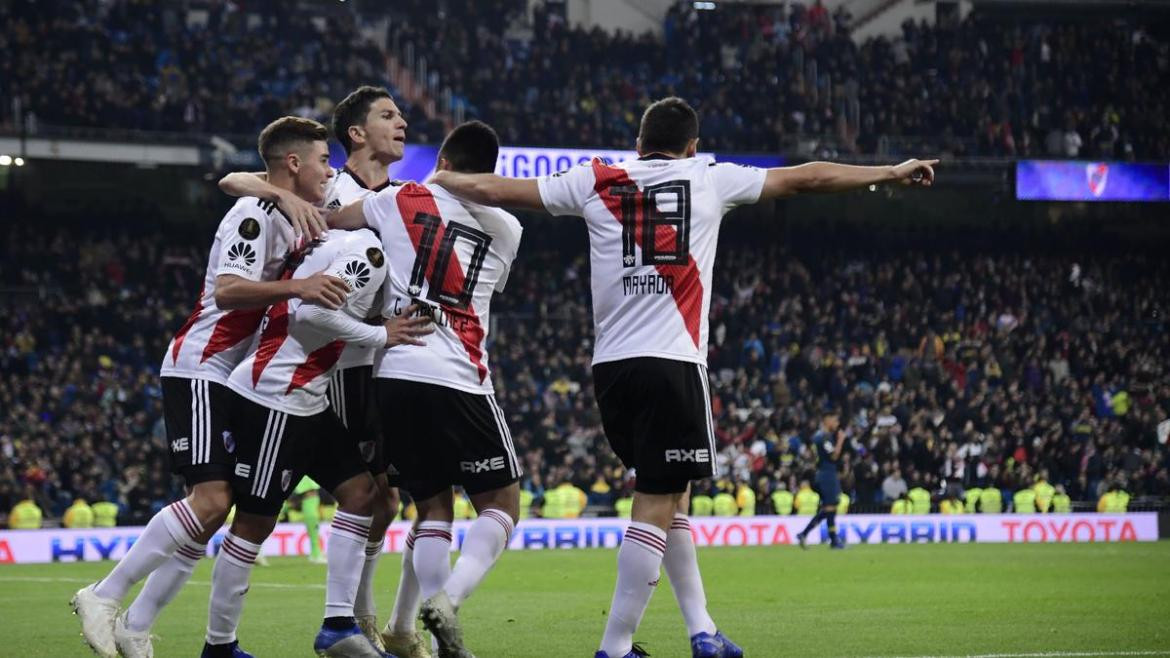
{"left": 220, "top": 85, "right": 425, "bottom": 658}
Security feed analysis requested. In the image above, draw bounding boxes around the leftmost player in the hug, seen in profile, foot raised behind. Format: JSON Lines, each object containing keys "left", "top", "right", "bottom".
{"left": 71, "top": 117, "right": 347, "bottom": 658}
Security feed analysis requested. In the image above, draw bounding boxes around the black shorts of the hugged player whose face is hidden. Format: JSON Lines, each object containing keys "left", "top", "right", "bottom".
{"left": 230, "top": 392, "right": 367, "bottom": 516}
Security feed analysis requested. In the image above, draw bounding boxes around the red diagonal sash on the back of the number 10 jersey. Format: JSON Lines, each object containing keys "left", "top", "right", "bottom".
{"left": 397, "top": 183, "right": 488, "bottom": 384}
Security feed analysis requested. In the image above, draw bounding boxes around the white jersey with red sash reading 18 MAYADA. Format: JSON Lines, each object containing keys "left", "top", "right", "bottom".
{"left": 538, "top": 156, "right": 765, "bottom": 364}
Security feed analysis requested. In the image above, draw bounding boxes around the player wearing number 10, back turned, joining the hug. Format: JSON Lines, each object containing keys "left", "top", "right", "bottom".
{"left": 330, "top": 122, "right": 522, "bottom": 658}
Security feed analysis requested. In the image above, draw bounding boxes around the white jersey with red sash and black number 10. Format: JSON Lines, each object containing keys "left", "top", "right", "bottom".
{"left": 363, "top": 183, "right": 522, "bottom": 393}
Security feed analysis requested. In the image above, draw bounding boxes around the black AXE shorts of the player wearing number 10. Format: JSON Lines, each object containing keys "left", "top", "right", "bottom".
{"left": 374, "top": 379, "right": 521, "bottom": 500}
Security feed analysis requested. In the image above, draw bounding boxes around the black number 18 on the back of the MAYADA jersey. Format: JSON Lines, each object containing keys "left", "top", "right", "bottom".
{"left": 610, "top": 180, "right": 690, "bottom": 267}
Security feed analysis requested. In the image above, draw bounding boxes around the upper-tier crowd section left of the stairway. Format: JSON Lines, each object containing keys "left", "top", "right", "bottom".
{"left": 0, "top": 0, "right": 443, "bottom": 142}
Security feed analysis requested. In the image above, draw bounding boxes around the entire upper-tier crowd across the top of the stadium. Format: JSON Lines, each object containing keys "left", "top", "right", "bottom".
{"left": 0, "top": 0, "right": 1170, "bottom": 159}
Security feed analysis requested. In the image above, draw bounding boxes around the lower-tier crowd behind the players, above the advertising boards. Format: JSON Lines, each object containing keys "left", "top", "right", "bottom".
{"left": 0, "top": 217, "right": 1170, "bottom": 523}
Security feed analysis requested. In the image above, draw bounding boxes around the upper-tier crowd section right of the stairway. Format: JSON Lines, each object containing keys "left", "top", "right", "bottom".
{"left": 392, "top": 0, "right": 1170, "bottom": 158}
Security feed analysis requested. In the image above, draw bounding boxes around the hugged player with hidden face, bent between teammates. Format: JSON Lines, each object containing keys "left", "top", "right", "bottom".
{"left": 204, "top": 227, "right": 431, "bottom": 658}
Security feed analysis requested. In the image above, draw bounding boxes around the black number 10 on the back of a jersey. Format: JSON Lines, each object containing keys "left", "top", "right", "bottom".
{"left": 410, "top": 212, "right": 491, "bottom": 310}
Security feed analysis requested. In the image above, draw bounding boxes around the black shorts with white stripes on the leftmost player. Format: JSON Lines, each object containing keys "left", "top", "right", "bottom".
{"left": 163, "top": 377, "right": 235, "bottom": 487}
